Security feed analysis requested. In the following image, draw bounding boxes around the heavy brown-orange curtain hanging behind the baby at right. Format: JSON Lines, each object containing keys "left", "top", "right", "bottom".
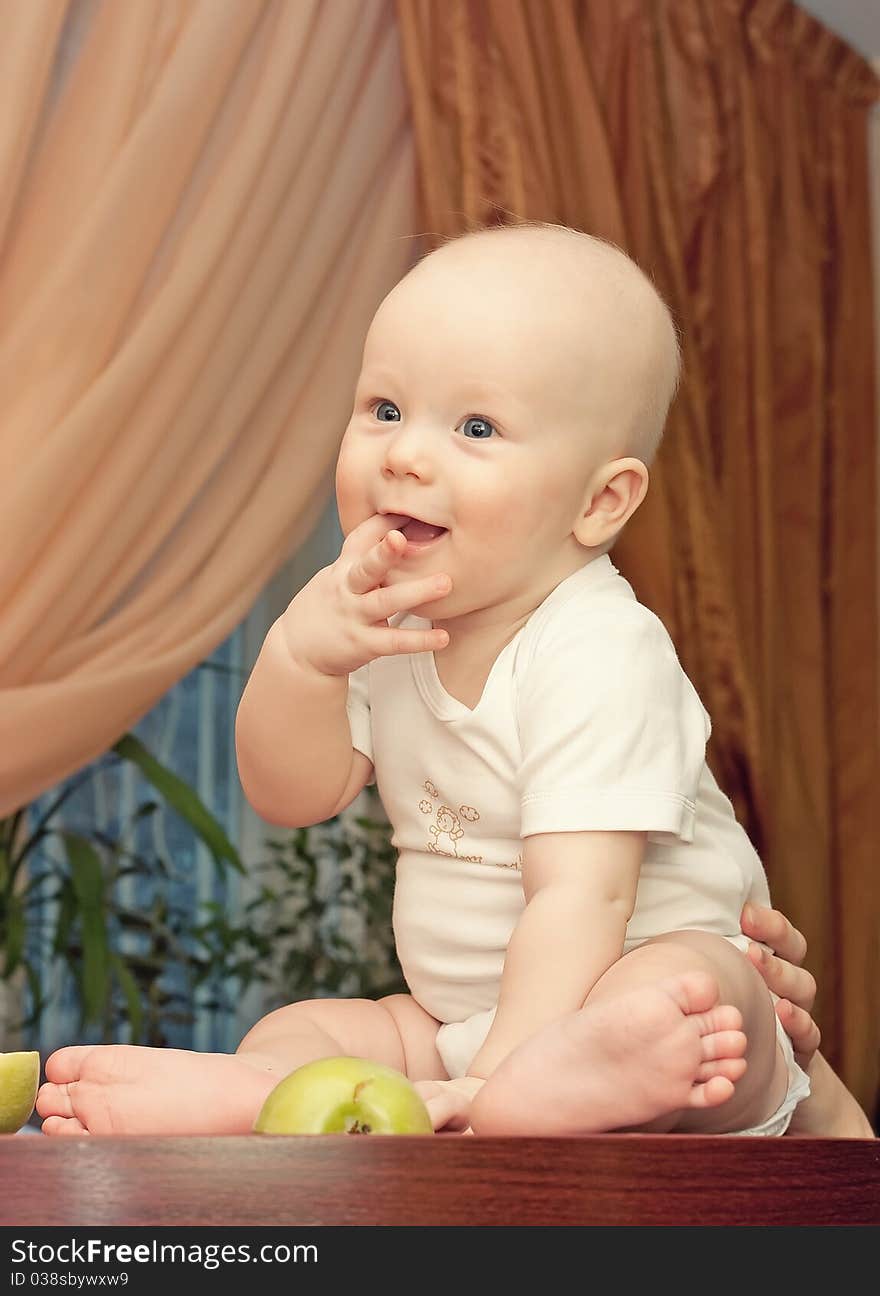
{"left": 397, "top": 0, "right": 880, "bottom": 1112}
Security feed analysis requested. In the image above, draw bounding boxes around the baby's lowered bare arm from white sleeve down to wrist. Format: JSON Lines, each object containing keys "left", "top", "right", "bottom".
{"left": 468, "top": 832, "right": 647, "bottom": 1078}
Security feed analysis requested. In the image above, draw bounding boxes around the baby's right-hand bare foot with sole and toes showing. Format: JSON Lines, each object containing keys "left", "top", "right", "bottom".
{"left": 470, "top": 972, "right": 747, "bottom": 1135}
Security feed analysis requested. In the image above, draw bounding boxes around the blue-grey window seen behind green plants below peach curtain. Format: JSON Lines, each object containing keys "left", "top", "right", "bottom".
{"left": 26, "top": 499, "right": 342, "bottom": 1058}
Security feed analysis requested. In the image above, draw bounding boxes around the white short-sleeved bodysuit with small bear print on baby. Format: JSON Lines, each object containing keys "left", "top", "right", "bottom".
{"left": 347, "top": 556, "right": 802, "bottom": 1130}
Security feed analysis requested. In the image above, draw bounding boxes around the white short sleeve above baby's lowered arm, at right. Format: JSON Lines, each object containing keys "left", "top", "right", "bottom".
{"left": 517, "top": 604, "right": 712, "bottom": 842}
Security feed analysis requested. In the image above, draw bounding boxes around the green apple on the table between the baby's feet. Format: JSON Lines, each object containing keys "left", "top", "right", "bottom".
{"left": 254, "top": 1058, "right": 434, "bottom": 1134}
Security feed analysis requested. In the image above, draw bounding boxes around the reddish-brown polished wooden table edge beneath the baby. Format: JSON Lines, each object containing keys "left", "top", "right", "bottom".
{"left": 0, "top": 1134, "right": 880, "bottom": 1227}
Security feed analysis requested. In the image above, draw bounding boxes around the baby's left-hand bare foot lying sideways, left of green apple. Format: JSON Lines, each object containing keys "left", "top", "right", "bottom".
{"left": 36, "top": 1045, "right": 281, "bottom": 1135}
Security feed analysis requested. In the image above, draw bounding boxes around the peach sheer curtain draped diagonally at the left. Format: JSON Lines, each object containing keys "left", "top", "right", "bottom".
{"left": 0, "top": 0, "right": 415, "bottom": 816}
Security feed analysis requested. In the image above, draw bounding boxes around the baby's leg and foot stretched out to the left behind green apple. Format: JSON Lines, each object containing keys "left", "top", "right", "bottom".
{"left": 36, "top": 995, "right": 446, "bottom": 1135}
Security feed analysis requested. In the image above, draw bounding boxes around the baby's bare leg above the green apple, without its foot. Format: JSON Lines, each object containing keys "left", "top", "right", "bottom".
{"left": 238, "top": 994, "right": 446, "bottom": 1080}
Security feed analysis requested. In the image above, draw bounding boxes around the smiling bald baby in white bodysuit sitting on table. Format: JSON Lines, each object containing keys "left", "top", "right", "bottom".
{"left": 38, "top": 224, "right": 809, "bottom": 1134}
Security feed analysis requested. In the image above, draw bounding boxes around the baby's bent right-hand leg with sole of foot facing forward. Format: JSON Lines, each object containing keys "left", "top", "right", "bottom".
{"left": 470, "top": 932, "right": 788, "bottom": 1135}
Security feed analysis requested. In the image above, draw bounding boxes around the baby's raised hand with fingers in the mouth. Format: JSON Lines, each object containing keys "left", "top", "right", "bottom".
{"left": 279, "top": 513, "right": 452, "bottom": 675}
